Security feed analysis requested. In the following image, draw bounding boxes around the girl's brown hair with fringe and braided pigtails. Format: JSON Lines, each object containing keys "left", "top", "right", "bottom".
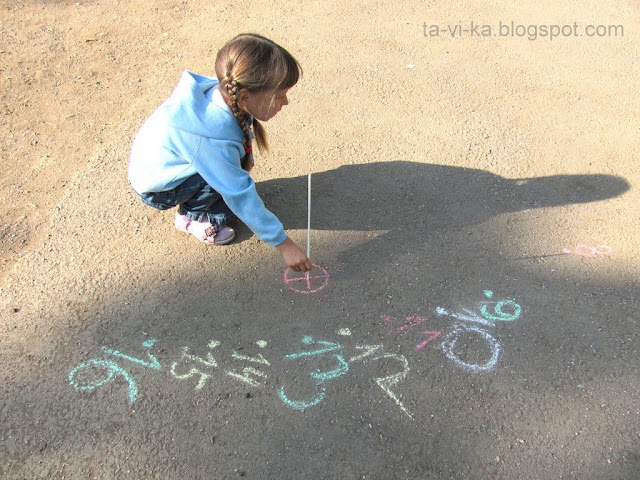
{"left": 216, "top": 33, "right": 302, "bottom": 158}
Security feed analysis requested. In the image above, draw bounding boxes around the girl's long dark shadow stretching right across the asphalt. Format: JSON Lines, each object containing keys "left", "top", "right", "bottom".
{"left": 251, "top": 161, "right": 629, "bottom": 242}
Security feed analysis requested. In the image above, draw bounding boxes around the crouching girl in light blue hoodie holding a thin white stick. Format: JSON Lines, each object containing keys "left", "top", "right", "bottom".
{"left": 129, "top": 34, "right": 312, "bottom": 272}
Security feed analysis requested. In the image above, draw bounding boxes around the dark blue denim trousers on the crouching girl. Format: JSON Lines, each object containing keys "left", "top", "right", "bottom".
{"left": 136, "top": 174, "right": 235, "bottom": 224}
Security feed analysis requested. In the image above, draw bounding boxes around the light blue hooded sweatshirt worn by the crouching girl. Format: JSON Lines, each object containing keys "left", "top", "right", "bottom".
{"left": 129, "top": 71, "right": 287, "bottom": 246}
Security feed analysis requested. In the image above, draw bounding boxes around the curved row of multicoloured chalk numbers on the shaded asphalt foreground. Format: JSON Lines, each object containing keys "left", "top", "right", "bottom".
{"left": 68, "top": 290, "right": 522, "bottom": 418}
